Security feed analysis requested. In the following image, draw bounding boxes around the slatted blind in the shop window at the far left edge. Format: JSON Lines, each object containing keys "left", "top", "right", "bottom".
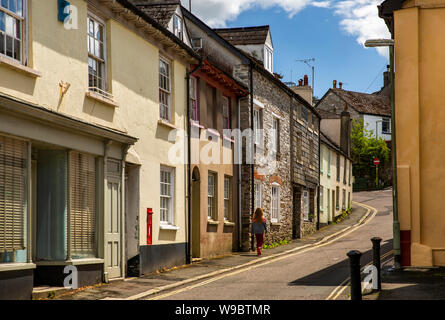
{"left": 0, "top": 136, "right": 27, "bottom": 252}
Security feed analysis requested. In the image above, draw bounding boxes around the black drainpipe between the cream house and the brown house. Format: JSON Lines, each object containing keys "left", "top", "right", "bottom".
{"left": 185, "top": 59, "right": 203, "bottom": 264}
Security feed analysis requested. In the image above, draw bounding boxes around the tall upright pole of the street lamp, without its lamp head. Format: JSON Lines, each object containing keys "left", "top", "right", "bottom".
{"left": 389, "top": 45, "right": 402, "bottom": 269}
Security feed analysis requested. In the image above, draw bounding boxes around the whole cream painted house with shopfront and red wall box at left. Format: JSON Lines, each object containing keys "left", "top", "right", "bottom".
{"left": 0, "top": 0, "right": 199, "bottom": 299}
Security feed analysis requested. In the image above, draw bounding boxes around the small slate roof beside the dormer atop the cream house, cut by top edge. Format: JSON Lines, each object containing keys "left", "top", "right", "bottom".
{"left": 130, "top": 0, "right": 181, "bottom": 28}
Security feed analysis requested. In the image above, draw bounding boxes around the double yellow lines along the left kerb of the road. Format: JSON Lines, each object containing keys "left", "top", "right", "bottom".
{"left": 146, "top": 202, "right": 378, "bottom": 300}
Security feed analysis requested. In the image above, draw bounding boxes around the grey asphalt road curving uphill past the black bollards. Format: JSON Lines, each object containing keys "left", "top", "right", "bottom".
{"left": 148, "top": 191, "right": 392, "bottom": 300}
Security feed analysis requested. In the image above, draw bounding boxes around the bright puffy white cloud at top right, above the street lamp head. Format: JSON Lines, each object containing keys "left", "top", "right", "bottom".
{"left": 334, "top": 0, "right": 391, "bottom": 57}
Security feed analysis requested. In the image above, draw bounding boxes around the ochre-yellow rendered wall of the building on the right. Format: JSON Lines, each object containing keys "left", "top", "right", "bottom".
{"left": 394, "top": 1, "right": 445, "bottom": 266}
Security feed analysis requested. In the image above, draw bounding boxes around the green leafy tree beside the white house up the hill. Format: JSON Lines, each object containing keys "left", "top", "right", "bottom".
{"left": 351, "top": 119, "right": 391, "bottom": 185}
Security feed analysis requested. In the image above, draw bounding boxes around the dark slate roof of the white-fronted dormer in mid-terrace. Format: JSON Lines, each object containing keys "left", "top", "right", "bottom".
{"left": 214, "top": 26, "right": 270, "bottom": 46}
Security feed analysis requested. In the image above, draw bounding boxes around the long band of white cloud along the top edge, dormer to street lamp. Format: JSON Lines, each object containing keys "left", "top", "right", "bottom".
{"left": 181, "top": 0, "right": 390, "bottom": 57}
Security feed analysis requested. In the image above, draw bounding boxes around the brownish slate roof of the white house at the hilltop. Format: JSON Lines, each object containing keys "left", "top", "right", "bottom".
{"left": 330, "top": 89, "right": 391, "bottom": 117}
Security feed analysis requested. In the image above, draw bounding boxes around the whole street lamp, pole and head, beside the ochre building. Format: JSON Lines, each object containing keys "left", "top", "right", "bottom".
{"left": 365, "top": 39, "right": 401, "bottom": 269}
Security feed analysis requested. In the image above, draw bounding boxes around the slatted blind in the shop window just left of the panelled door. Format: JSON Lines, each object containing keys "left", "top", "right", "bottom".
{"left": 70, "top": 152, "right": 96, "bottom": 257}
